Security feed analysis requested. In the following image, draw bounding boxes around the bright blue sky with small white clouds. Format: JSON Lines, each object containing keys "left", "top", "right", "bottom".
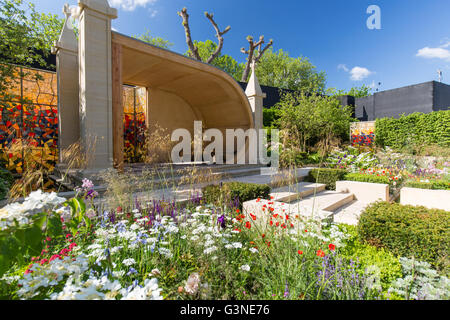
{"left": 32, "top": 0, "right": 450, "bottom": 91}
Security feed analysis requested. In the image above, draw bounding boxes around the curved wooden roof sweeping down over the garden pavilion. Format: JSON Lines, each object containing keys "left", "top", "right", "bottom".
{"left": 112, "top": 32, "right": 254, "bottom": 129}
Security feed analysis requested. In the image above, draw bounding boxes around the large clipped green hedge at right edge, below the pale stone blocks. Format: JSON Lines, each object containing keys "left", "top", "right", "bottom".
{"left": 357, "top": 202, "right": 450, "bottom": 271}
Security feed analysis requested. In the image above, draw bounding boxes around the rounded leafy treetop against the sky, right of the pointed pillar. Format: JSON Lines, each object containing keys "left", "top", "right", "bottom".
{"left": 256, "top": 49, "right": 326, "bottom": 93}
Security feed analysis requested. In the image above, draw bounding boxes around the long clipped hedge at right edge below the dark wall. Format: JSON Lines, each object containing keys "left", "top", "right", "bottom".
{"left": 375, "top": 110, "right": 450, "bottom": 149}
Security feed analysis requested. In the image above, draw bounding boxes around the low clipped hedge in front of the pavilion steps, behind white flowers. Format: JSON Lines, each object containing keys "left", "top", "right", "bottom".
{"left": 202, "top": 182, "right": 270, "bottom": 209}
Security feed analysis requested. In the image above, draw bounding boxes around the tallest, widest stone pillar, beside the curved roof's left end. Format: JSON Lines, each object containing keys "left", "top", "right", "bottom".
{"left": 78, "top": 0, "right": 117, "bottom": 171}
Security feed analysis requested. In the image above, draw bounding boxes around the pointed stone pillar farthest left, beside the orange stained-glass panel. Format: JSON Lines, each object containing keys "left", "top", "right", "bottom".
{"left": 52, "top": 4, "right": 80, "bottom": 164}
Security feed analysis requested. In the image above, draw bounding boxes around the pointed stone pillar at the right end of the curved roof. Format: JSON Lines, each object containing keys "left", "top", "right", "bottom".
{"left": 245, "top": 62, "right": 266, "bottom": 164}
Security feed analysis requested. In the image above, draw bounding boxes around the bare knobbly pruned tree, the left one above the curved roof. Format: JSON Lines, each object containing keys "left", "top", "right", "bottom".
{"left": 178, "top": 8, "right": 231, "bottom": 63}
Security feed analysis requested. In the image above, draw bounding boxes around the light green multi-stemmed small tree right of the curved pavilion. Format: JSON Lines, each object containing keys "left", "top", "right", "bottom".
{"left": 275, "top": 93, "right": 352, "bottom": 154}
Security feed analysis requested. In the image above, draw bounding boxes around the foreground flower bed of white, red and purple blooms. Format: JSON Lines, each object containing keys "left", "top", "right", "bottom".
{"left": 0, "top": 185, "right": 448, "bottom": 300}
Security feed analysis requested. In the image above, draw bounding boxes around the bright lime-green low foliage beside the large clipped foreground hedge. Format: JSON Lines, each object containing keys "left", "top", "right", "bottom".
{"left": 339, "top": 225, "right": 402, "bottom": 291}
